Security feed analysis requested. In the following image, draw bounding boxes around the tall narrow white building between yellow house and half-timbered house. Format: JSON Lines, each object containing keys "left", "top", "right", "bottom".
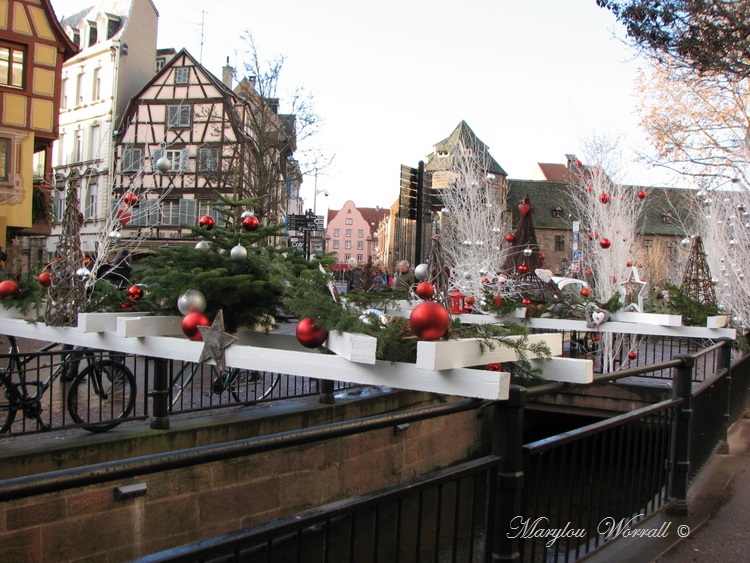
{"left": 47, "top": 0, "right": 159, "bottom": 253}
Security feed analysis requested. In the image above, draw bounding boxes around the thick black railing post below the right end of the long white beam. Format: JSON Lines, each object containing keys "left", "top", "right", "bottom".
{"left": 492, "top": 385, "right": 528, "bottom": 562}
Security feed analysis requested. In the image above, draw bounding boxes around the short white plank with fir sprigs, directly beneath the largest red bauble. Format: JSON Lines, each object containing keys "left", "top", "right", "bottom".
{"left": 417, "top": 333, "right": 562, "bottom": 370}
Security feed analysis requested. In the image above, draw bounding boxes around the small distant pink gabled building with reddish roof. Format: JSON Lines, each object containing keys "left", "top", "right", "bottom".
{"left": 325, "top": 200, "right": 390, "bottom": 265}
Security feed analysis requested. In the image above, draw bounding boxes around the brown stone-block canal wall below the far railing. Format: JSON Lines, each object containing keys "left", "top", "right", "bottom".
{"left": 0, "top": 394, "right": 482, "bottom": 562}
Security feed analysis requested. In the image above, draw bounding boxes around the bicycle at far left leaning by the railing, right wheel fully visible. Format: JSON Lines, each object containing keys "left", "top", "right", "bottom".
{"left": 0, "top": 336, "right": 136, "bottom": 433}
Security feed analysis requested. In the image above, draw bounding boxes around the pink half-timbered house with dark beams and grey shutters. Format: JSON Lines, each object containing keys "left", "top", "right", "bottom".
{"left": 113, "top": 46, "right": 299, "bottom": 245}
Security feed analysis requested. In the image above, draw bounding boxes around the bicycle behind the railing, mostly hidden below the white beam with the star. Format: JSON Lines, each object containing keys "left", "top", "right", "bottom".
{"left": 169, "top": 362, "right": 281, "bottom": 410}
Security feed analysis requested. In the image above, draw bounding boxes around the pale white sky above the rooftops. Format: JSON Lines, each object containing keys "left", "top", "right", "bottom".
{"left": 52, "top": 0, "right": 663, "bottom": 214}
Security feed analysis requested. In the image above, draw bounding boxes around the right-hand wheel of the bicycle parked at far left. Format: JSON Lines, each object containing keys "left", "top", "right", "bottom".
{"left": 68, "top": 360, "right": 136, "bottom": 432}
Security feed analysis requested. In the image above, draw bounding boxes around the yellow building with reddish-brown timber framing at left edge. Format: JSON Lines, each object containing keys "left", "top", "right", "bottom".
{"left": 0, "top": 0, "right": 77, "bottom": 258}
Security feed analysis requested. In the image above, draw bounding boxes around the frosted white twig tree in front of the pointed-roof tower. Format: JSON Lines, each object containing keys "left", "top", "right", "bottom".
{"left": 440, "top": 139, "right": 510, "bottom": 311}
